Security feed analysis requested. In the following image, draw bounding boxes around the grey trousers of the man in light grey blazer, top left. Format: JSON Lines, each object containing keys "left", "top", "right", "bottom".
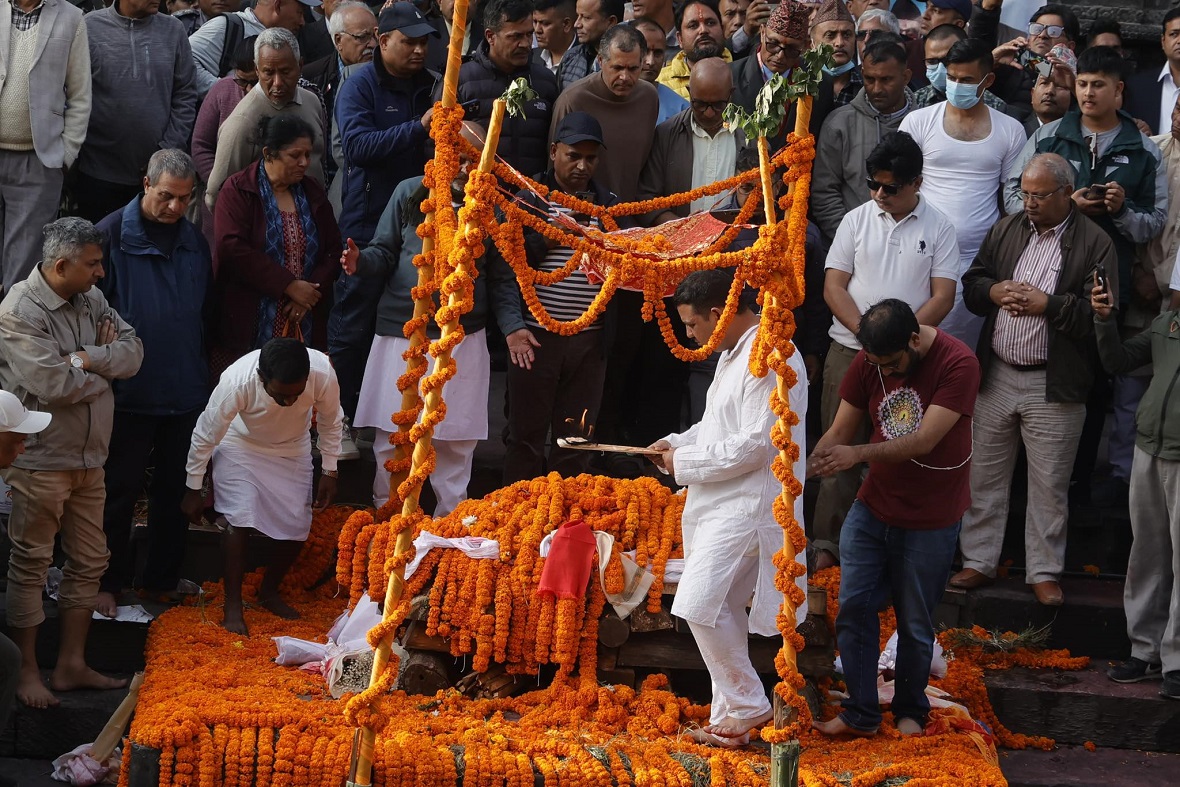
{"left": 0, "top": 150, "right": 65, "bottom": 293}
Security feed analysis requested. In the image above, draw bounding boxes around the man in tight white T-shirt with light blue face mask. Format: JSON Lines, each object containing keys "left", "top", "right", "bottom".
{"left": 902, "top": 39, "right": 1025, "bottom": 348}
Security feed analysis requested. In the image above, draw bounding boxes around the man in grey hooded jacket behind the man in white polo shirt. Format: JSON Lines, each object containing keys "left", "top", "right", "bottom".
{"left": 811, "top": 44, "right": 915, "bottom": 242}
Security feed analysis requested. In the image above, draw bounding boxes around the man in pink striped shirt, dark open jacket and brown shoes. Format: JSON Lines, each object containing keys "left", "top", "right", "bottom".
{"left": 950, "top": 153, "right": 1119, "bottom": 606}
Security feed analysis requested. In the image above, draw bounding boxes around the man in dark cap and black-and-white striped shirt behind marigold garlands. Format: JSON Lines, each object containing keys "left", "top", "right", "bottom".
{"left": 497, "top": 112, "right": 617, "bottom": 485}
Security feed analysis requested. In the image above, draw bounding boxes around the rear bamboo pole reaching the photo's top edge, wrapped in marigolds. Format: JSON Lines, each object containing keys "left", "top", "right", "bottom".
{"left": 376, "top": 0, "right": 468, "bottom": 500}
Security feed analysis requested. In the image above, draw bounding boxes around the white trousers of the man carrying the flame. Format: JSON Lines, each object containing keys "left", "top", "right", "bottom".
{"left": 688, "top": 557, "right": 771, "bottom": 724}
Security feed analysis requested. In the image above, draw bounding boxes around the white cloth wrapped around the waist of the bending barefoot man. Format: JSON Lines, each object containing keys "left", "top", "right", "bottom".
{"left": 214, "top": 441, "right": 312, "bottom": 542}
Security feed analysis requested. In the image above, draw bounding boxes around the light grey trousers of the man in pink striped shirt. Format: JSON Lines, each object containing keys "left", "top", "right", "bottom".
{"left": 959, "top": 358, "right": 1086, "bottom": 584}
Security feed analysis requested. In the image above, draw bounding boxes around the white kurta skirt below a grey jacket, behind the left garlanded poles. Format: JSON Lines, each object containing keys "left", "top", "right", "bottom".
{"left": 353, "top": 330, "right": 492, "bottom": 448}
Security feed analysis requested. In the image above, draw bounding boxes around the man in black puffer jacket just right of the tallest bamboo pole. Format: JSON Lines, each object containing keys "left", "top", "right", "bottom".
{"left": 446, "top": 0, "right": 558, "bottom": 172}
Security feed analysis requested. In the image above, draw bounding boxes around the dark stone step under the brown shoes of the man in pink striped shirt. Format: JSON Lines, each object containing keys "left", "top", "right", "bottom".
{"left": 936, "top": 577, "right": 1130, "bottom": 660}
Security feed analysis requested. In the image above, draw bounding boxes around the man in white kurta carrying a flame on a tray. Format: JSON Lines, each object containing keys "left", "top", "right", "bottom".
{"left": 651, "top": 270, "right": 807, "bottom": 747}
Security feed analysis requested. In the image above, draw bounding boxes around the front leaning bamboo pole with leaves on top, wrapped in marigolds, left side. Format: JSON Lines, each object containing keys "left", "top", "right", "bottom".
{"left": 348, "top": 98, "right": 506, "bottom": 787}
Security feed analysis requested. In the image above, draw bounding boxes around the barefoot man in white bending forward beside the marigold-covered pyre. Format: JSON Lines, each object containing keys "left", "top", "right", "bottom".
{"left": 181, "top": 339, "right": 343, "bottom": 636}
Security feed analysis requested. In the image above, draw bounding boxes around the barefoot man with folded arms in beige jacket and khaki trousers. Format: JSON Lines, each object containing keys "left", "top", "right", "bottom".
{"left": 0, "top": 218, "right": 144, "bottom": 708}
